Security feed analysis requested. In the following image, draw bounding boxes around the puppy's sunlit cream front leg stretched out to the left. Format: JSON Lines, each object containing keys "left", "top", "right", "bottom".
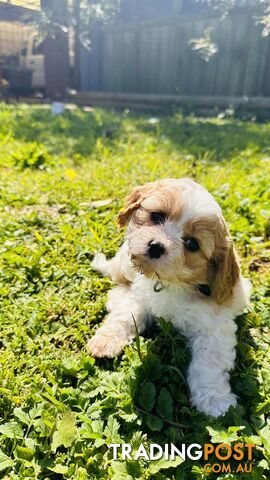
{"left": 88, "top": 286, "right": 148, "bottom": 358}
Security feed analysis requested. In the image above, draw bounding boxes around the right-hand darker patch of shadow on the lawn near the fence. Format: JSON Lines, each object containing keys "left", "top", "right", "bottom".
{"left": 135, "top": 114, "right": 269, "bottom": 161}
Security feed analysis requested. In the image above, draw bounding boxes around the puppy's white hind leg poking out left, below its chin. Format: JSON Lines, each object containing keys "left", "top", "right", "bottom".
{"left": 91, "top": 242, "right": 135, "bottom": 283}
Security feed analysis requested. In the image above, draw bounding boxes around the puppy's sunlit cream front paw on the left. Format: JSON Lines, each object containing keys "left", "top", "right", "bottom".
{"left": 87, "top": 333, "right": 128, "bottom": 358}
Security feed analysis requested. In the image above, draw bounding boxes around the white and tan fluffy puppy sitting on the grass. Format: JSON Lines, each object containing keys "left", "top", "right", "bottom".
{"left": 88, "top": 178, "right": 250, "bottom": 417}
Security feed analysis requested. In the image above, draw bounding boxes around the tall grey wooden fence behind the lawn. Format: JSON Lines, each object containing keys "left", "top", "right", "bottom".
{"left": 80, "top": 9, "right": 270, "bottom": 97}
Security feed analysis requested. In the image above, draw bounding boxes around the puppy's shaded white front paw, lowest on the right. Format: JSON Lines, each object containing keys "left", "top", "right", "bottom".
{"left": 196, "top": 393, "right": 237, "bottom": 417}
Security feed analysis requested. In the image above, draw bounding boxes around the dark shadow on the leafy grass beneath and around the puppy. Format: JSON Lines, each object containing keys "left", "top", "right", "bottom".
{"left": 130, "top": 315, "right": 262, "bottom": 443}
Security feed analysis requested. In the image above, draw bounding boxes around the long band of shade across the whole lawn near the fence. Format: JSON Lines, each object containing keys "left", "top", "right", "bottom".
{"left": 6, "top": 108, "right": 270, "bottom": 161}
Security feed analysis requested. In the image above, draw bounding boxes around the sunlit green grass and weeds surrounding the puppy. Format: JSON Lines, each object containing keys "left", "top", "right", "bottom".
{"left": 0, "top": 105, "right": 270, "bottom": 480}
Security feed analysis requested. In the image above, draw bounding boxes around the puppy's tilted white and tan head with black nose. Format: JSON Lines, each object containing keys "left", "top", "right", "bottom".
{"left": 118, "top": 179, "right": 239, "bottom": 303}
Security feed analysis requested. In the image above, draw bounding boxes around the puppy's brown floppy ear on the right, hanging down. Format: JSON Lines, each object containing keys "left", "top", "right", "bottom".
{"left": 213, "top": 223, "right": 240, "bottom": 304}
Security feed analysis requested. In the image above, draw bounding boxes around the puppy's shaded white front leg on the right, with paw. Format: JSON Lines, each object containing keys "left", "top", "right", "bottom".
{"left": 188, "top": 322, "right": 237, "bottom": 417}
